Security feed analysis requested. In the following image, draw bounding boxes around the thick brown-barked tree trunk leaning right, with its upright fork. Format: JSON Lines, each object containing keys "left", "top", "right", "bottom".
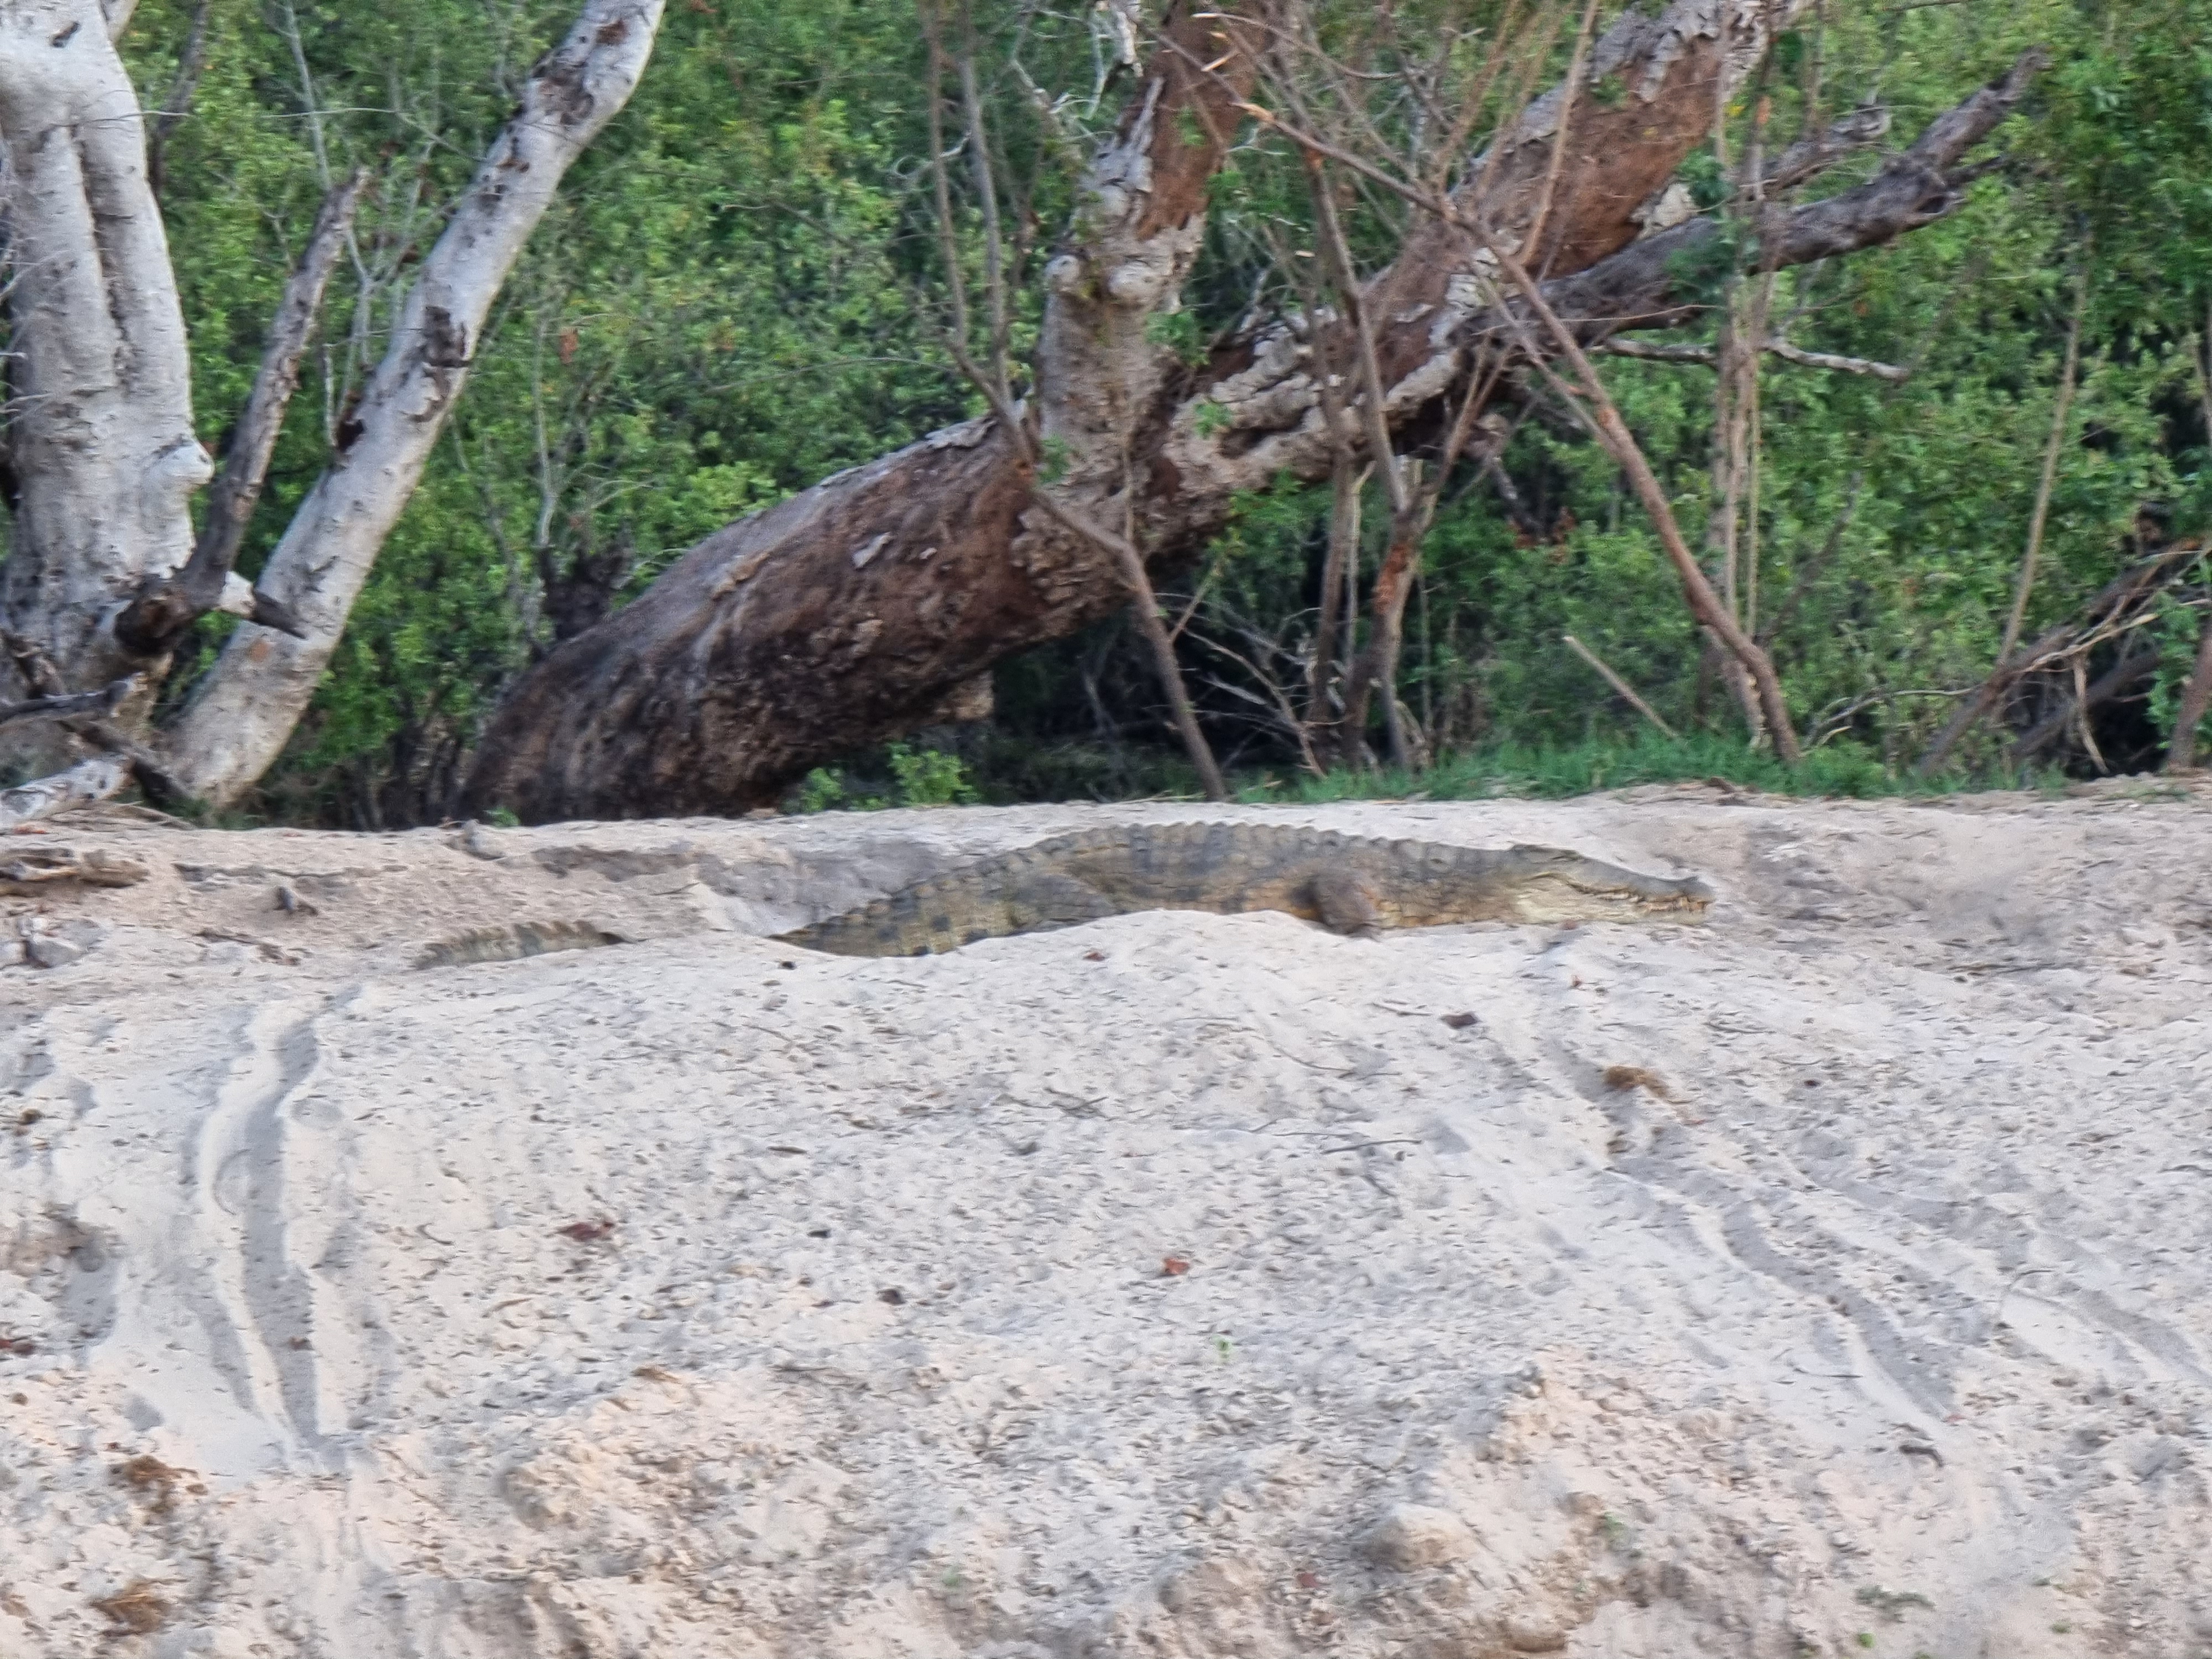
{"left": 465, "top": 0, "right": 1774, "bottom": 818}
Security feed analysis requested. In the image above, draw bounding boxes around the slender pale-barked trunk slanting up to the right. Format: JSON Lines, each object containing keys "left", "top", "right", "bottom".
{"left": 164, "top": 0, "right": 664, "bottom": 803}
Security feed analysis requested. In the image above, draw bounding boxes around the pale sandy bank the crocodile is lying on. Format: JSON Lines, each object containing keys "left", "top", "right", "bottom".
{"left": 0, "top": 787, "right": 2212, "bottom": 1659}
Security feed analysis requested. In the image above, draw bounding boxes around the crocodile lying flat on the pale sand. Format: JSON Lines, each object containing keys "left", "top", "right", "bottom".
{"left": 776, "top": 823, "right": 1712, "bottom": 956}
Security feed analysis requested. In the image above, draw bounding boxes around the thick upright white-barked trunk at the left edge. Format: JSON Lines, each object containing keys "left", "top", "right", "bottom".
{"left": 0, "top": 0, "right": 212, "bottom": 770}
